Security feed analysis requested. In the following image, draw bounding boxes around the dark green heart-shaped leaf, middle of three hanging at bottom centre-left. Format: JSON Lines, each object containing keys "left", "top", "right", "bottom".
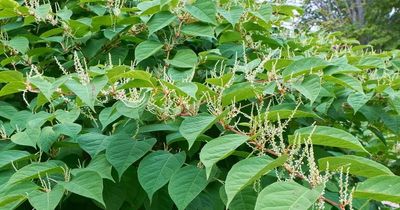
{"left": 138, "top": 150, "right": 186, "bottom": 202}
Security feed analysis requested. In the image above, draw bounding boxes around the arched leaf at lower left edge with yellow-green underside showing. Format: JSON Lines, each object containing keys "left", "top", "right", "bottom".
{"left": 8, "top": 160, "right": 64, "bottom": 185}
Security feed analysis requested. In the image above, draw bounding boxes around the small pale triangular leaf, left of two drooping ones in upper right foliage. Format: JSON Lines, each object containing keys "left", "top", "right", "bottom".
{"left": 293, "top": 74, "right": 321, "bottom": 104}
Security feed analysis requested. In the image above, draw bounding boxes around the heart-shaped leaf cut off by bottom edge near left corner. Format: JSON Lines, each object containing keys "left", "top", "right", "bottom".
{"left": 28, "top": 185, "right": 64, "bottom": 210}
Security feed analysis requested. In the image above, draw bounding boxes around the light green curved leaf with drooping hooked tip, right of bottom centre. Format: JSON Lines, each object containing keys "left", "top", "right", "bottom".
{"left": 200, "top": 134, "right": 249, "bottom": 179}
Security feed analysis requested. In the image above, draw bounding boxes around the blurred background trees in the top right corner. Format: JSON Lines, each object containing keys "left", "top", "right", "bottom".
{"left": 302, "top": 0, "right": 400, "bottom": 50}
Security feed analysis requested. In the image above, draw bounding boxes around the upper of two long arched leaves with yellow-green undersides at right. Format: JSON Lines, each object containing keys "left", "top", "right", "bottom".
{"left": 289, "top": 126, "right": 368, "bottom": 153}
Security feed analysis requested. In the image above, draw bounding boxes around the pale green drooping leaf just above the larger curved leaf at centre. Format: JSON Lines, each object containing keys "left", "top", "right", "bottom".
{"left": 179, "top": 114, "right": 217, "bottom": 149}
